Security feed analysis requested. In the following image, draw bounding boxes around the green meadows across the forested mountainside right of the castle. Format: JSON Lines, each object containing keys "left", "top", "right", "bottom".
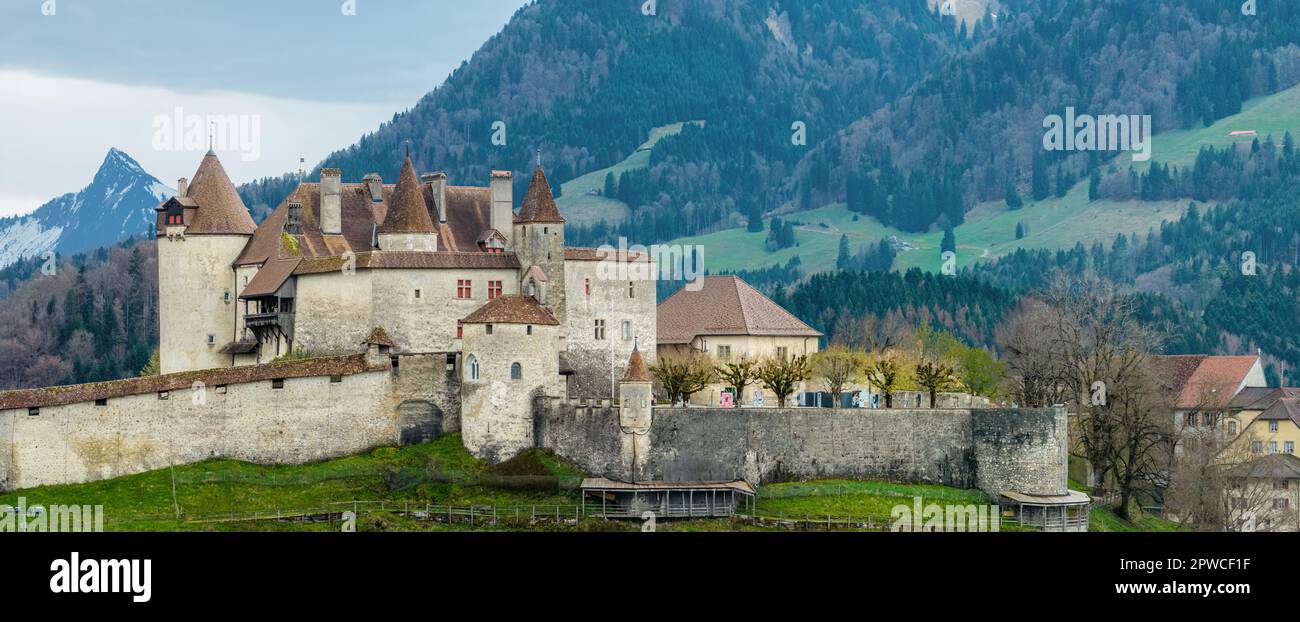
{"left": 673, "top": 81, "right": 1300, "bottom": 273}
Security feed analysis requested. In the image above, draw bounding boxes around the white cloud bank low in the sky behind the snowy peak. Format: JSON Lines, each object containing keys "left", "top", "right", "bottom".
{"left": 0, "top": 70, "right": 400, "bottom": 216}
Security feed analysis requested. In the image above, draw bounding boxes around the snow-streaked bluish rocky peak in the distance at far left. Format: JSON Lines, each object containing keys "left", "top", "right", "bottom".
{"left": 0, "top": 148, "right": 176, "bottom": 268}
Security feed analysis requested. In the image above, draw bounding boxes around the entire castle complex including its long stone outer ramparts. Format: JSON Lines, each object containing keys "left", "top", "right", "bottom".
{"left": 0, "top": 152, "right": 1087, "bottom": 524}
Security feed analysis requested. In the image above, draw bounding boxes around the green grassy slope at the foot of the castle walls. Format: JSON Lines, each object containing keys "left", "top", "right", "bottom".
{"left": 0, "top": 435, "right": 1055, "bottom": 531}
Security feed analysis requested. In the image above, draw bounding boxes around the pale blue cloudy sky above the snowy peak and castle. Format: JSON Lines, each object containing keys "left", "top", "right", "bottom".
{"left": 0, "top": 0, "right": 527, "bottom": 216}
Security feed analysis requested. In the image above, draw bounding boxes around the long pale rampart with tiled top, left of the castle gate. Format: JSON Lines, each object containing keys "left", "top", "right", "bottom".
{"left": 0, "top": 357, "right": 444, "bottom": 489}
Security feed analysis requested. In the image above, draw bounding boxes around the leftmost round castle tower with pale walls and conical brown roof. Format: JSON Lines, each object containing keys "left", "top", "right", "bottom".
{"left": 156, "top": 150, "right": 256, "bottom": 373}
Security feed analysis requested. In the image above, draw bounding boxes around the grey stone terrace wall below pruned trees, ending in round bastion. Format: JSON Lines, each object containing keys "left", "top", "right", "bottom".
{"left": 537, "top": 401, "right": 1066, "bottom": 494}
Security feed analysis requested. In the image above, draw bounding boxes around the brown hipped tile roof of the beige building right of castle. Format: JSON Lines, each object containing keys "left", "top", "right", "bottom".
{"left": 657, "top": 276, "right": 822, "bottom": 344}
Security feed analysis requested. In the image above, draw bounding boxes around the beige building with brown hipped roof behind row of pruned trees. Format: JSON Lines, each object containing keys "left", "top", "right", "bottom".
{"left": 658, "top": 276, "right": 822, "bottom": 406}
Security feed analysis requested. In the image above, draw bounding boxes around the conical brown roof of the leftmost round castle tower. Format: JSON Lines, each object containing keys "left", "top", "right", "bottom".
{"left": 157, "top": 151, "right": 257, "bottom": 236}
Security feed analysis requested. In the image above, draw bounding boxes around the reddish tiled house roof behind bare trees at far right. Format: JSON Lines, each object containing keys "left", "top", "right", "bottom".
{"left": 1152, "top": 354, "right": 1260, "bottom": 409}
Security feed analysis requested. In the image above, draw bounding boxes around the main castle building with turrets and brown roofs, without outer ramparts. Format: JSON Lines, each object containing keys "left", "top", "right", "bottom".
{"left": 157, "top": 151, "right": 655, "bottom": 458}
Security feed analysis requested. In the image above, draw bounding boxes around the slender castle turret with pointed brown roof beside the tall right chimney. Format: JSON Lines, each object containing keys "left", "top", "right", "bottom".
{"left": 511, "top": 165, "right": 564, "bottom": 324}
